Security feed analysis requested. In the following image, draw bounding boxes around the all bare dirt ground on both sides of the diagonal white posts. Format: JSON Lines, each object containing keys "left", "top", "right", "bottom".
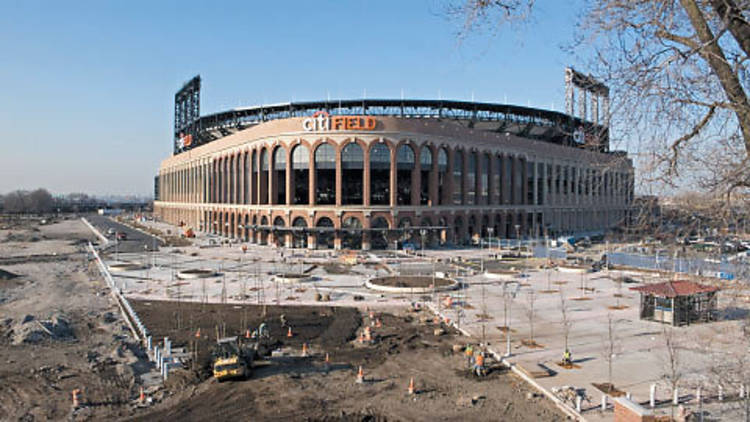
{"left": 0, "top": 219, "right": 565, "bottom": 421}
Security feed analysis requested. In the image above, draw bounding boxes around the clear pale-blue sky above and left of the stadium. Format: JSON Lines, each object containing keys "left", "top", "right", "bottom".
{"left": 0, "top": 0, "right": 588, "bottom": 195}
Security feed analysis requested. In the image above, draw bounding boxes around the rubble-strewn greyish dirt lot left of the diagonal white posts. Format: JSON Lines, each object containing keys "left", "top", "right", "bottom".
{"left": 0, "top": 219, "right": 151, "bottom": 421}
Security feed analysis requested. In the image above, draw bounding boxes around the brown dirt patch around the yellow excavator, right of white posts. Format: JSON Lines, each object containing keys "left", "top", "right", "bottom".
{"left": 129, "top": 302, "right": 565, "bottom": 421}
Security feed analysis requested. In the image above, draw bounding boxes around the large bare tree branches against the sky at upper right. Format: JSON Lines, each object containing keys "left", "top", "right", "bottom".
{"left": 448, "top": 0, "right": 750, "bottom": 200}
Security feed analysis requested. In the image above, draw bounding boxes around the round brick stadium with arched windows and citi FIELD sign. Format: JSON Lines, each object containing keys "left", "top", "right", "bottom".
{"left": 154, "top": 68, "right": 634, "bottom": 249}
